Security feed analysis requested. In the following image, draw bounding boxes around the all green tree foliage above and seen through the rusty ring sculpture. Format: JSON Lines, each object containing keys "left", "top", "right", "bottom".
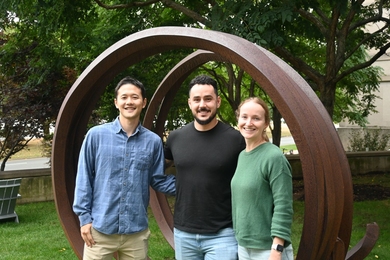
{"left": 0, "top": 0, "right": 390, "bottom": 165}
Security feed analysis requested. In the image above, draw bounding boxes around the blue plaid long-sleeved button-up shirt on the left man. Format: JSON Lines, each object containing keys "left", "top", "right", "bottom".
{"left": 73, "top": 118, "right": 175, "bottom": 234}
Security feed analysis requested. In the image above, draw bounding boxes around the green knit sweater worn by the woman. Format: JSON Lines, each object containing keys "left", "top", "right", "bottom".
{"left": 231, "top": 143, "right": 293, "bottom": 250}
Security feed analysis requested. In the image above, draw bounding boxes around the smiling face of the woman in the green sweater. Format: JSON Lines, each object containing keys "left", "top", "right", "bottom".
{"left": 238, "top": 100, "right": 269, "bottom": 142}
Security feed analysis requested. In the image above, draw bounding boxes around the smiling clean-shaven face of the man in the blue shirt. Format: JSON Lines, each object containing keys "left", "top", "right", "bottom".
{"left": 114, "top": 84, "right": 146, "bottom": 121}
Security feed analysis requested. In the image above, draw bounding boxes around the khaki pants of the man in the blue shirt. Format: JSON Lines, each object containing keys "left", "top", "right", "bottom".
{"left": 83, "top": 228, "right": 150, "bottom": 260}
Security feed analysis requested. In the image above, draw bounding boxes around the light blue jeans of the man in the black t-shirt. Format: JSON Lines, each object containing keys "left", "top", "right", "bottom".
{"left": 174, "top": 228, "right": 238, "bottom": 260}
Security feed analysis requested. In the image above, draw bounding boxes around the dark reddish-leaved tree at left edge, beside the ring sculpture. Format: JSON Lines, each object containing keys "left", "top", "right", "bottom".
{"left": 0, "top": 27, "right": 76, "bottom": 171}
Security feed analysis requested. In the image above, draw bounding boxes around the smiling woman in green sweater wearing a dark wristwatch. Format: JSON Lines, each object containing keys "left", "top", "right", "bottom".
{"left": 231, "top": 97, "right": 294, "bottom": 260}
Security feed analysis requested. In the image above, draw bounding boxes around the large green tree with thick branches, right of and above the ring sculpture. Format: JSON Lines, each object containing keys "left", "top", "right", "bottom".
{"left": 90, "top": 0, "right": 390, "bottom": 142}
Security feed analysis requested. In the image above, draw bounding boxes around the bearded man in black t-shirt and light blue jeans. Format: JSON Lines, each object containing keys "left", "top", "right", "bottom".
{"left": 165, "top": 75, "right": 245, "bottom": 260}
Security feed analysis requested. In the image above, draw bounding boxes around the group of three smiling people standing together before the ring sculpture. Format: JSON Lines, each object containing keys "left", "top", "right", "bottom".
{"left": 73, "top": 75, "right": 293, "bottom": 260}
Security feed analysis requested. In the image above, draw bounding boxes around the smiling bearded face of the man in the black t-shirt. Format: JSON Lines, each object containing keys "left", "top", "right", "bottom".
{"left": 188, "top": 84, "right": 221, "bottom": 127}
